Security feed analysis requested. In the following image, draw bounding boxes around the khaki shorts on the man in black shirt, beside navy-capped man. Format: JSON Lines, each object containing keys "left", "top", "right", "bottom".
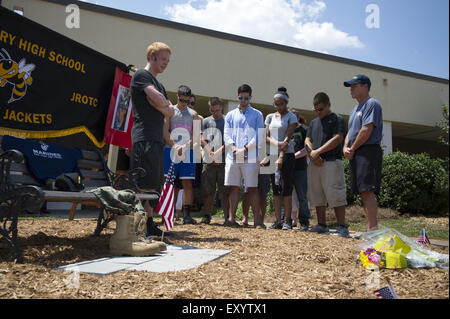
{"left": 307, "top": 160, "right": 347, "bottom": 208}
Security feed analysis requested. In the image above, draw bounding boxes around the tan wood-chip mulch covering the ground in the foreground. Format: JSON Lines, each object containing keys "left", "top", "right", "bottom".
{"left": 0, "top": 211, "right": 449, "bottom": 299}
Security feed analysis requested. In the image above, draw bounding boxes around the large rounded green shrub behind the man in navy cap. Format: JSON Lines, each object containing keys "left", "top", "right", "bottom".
{"left": 377, "top": 152, "right": 449, "bottom": 215}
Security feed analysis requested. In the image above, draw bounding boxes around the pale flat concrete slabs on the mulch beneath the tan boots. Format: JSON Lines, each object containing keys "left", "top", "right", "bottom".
{"left": 55, "top": 245, "right": 231, "bottom": 275}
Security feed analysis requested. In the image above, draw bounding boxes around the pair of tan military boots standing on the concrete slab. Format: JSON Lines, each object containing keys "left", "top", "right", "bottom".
{"left": 109, "top": 214, "right": 167, "bottom": 257}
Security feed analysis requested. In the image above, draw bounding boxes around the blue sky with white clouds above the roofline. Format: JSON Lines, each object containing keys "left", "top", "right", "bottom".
{"left": 84, "top": 0, "right": 449, "bottom": 79}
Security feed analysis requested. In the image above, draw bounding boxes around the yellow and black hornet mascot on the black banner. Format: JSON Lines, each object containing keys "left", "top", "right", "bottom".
{"left": 0, "top": 48, "right": 35, "bottom": 103}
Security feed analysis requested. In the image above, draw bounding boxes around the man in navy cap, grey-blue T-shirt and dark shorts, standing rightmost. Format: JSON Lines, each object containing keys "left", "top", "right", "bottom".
{"left": 343, "top": 74, "right": 383, "bottom": 230}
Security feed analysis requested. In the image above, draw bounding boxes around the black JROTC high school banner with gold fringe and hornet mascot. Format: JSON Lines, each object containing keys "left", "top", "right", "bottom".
{"left": 0, "top": 7, "right": 126, "bottom": 147}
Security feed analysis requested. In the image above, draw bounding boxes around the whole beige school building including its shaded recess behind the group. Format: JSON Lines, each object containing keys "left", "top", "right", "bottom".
{"left": 0, "top": 0, "right": 449, "bottom": 156}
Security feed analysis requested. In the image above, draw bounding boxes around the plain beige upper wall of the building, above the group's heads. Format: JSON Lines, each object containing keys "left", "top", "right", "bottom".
{"left": 2, "top": 0, "right": 449, "bottom": 146}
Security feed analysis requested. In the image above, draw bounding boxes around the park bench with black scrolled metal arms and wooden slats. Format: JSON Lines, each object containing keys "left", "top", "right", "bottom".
{"left": 0, "top": 136, "right": 159, "bottom": 263}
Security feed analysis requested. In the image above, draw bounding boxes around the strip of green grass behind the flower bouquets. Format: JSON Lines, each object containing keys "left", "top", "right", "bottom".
{"left": 349, "top": 217, "right": 449, "bottom": 240}
